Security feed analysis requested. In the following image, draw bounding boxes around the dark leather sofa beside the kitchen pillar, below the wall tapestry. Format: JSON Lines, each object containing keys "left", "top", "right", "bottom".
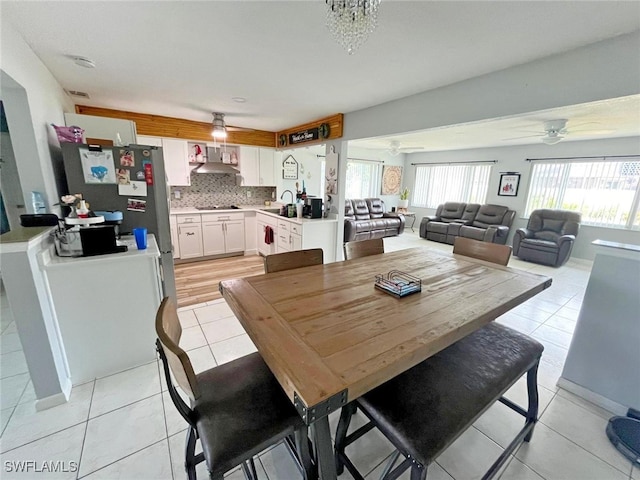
{"left": 344, "top": 198, "right": 405, "bottom": 242}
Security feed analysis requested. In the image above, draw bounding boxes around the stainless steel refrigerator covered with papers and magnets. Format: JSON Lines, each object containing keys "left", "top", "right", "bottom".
{"left": 61, "top": 143, "right": 176, "bottom": 301}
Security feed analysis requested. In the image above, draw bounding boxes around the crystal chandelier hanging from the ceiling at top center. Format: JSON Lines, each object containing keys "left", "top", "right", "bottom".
{"left": 325, "top": 0, "right": 381, "bottom": 55}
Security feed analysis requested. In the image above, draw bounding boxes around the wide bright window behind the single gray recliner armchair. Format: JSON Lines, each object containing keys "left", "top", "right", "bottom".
{"left": 525, "top": 157, "right": 640, "bottom": 230}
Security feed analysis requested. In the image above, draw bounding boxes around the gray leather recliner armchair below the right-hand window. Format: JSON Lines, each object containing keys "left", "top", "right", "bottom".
{"left": 513, "top": 209, "right": 582, "bottom": 267}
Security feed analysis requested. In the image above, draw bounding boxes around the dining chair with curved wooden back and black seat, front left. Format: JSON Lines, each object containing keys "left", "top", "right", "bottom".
{"left": 156, "top": 298, "right": 317, "bottom": 480}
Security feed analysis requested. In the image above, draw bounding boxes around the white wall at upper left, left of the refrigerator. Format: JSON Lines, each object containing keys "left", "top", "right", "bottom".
{"left": 0, "top": 17, "right": 74, "bottom": 213}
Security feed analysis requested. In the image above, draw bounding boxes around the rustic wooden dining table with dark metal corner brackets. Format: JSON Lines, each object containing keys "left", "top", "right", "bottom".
{"left": 220, "top": 247, "right": 551, "bottom": 480}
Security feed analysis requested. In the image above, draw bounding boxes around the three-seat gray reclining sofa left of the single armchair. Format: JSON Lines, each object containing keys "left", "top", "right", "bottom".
{"left": 420, "top": 202, "right": 516, "bottom": 245}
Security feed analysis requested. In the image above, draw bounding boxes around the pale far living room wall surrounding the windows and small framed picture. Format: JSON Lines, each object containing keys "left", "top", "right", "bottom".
{"left": 405, "top": 137, "right": 640, "bottom": 260}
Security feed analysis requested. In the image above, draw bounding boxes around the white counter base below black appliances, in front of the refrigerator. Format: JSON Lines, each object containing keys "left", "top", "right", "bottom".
{"left": 39, "top": 234, "right": 162, "bottom": 385}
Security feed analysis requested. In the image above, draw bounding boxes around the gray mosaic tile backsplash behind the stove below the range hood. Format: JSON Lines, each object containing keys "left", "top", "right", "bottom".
{"left": 171, "top": 173, "right": 276, "bottom": 208}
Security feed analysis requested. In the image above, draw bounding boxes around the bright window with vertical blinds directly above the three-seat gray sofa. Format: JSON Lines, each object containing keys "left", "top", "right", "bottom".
{"left": 411, "top": 164, "right": 491, "bottom": 208}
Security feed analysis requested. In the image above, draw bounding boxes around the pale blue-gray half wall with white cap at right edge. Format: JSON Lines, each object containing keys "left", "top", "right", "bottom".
{"left": 558, "top": 240, "right": 640, "bottom": 415}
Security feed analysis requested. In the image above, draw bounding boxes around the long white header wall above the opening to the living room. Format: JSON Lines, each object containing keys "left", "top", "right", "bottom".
{"left": 342, "top": 31, "right": 640, "bottom": 140}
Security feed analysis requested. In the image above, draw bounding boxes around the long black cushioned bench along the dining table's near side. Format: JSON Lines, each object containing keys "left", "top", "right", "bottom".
{"left": 335, "top": 323, "right": 544, "bottom": 480}
